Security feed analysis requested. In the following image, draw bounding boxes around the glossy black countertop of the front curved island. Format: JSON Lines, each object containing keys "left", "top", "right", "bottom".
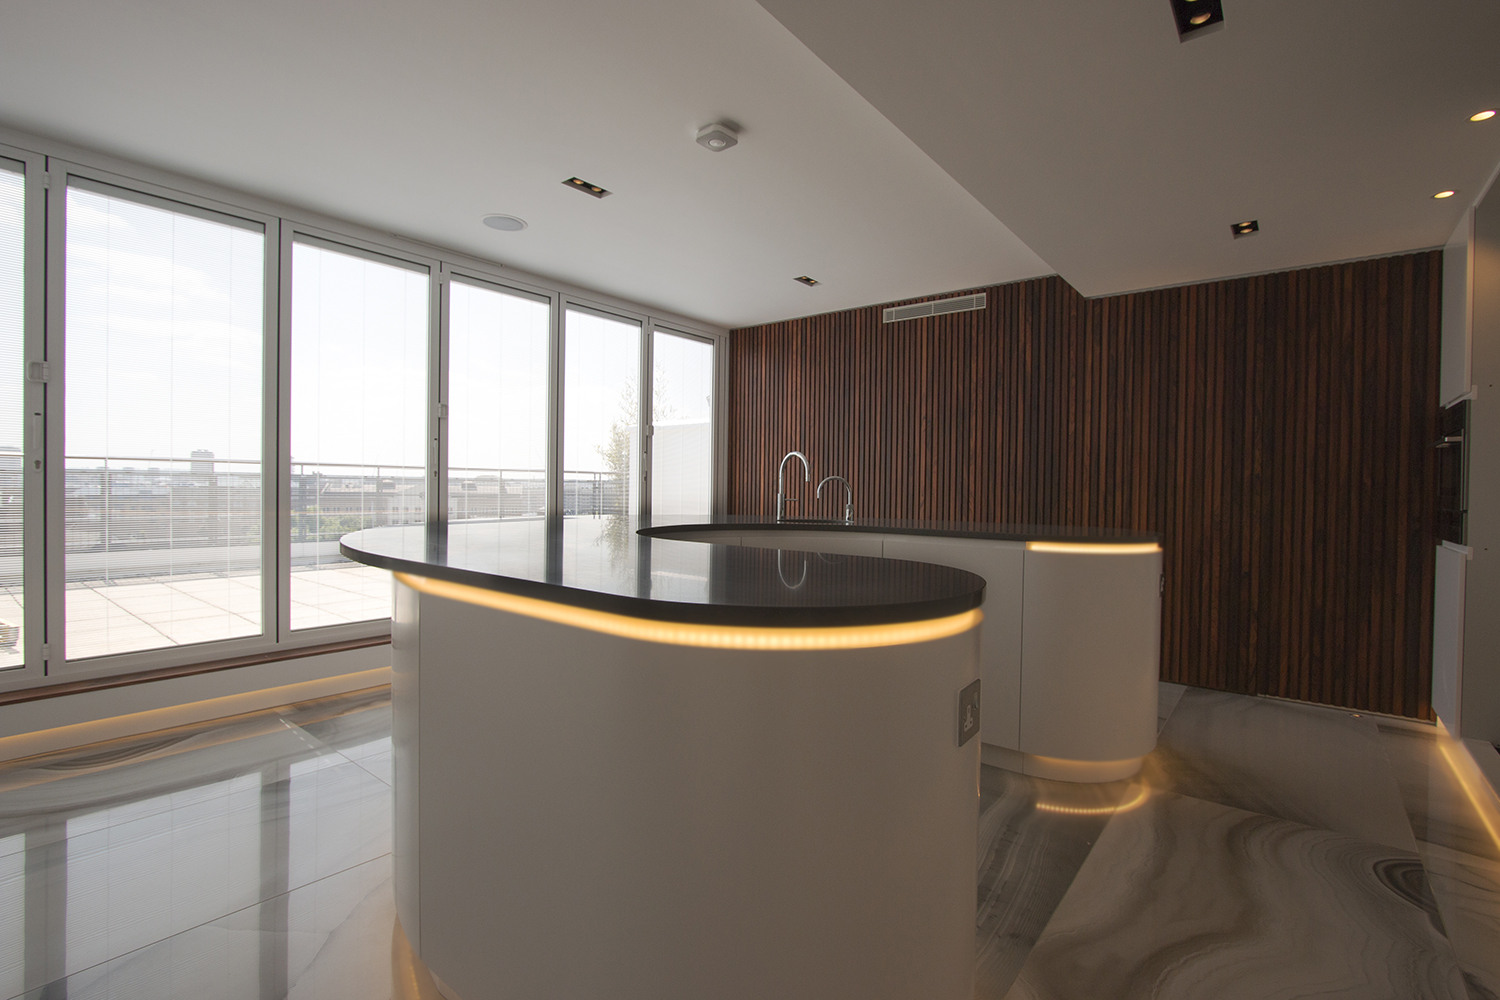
{"left": 339, "top": 516, "right": 984, "bottom": 627}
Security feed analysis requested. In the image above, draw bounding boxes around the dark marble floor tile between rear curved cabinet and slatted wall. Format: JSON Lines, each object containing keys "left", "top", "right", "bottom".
{"left": 1143, "top": 688, "right": 1416, "bottom": 853}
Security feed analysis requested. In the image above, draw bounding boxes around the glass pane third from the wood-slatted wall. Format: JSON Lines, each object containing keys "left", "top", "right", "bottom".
{"left": 449, "top": 282, "right": 551, "bottom": 520}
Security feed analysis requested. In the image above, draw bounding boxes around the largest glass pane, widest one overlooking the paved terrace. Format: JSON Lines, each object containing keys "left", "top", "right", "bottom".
{"left": 63, "top": 187, "right": 266, "bottom": 660}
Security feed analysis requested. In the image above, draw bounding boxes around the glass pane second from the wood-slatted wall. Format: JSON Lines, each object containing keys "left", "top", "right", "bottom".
{"left": 563, "top": 309, "right": 641, "bottom": 514}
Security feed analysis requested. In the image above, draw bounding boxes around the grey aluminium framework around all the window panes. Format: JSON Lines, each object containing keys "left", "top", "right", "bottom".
{"left": 0, "top": 126, "right": 731, "bottom": 691}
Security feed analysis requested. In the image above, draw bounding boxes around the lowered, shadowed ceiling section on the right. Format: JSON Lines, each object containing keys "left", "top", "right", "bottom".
{"left": 762, "top": 0, "right": 1500, "bottom": 298}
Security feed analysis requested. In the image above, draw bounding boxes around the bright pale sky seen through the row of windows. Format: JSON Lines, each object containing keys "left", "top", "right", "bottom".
{"left": 0, "top": 180, "right": 713, "bottom": 488}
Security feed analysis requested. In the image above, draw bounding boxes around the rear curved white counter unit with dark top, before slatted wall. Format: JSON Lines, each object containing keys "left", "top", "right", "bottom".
{"left": 648, "top": 519, "right": 1161, "bottom": 781}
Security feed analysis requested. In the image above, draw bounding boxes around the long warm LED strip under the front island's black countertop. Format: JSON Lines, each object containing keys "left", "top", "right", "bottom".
{"left": 395, "top": 573, "right": 984, "bottom": 651}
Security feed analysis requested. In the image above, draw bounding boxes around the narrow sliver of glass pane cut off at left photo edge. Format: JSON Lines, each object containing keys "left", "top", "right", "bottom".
{"left": 0, "top": 162, "right": 26, "bottom": 670}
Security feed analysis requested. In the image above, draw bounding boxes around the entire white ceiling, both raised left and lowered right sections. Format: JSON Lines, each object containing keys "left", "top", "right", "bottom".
{"left": 0, "top": 0, "right": 1500, "bottom": 327}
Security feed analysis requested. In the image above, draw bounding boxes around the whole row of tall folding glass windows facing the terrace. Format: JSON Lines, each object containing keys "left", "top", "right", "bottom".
{"left": 0, "top": 128, "right": 723, "bottom": 692}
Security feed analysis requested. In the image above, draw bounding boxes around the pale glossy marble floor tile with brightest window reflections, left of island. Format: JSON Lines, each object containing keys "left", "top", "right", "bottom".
{"left": 0, "top": 712, "right": 392, "bottom": 996}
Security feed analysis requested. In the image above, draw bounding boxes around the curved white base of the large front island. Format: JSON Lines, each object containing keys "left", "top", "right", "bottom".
{"left": 393, "top": 574, "right": 981, "bottom": 1000}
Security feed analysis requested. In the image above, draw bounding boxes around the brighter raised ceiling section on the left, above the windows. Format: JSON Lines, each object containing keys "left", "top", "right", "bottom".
{"left": 0, "top": 0, "right": 1050, "bottom": 327}
